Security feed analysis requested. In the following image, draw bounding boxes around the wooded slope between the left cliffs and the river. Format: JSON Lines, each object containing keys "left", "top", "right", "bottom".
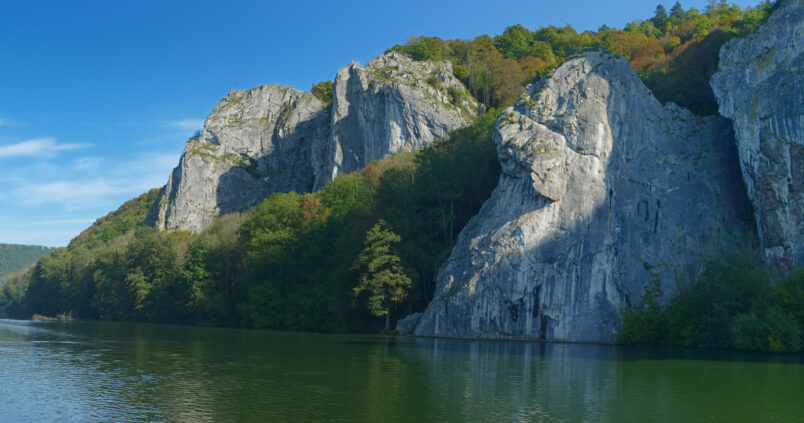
{"left": 0, "top": 110, "right": 500, "bottom": 331}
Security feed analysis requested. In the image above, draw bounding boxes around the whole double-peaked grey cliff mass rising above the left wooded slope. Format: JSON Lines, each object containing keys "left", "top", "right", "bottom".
{"left": 146, "top": 53, "right": 477, "bottom": 232}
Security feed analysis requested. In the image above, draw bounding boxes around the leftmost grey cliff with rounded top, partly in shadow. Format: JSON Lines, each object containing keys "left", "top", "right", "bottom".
{"left": 146, "top": 85, "right": 329, "bottom": 232}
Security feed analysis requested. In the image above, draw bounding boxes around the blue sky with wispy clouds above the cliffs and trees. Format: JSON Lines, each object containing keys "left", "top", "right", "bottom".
{"left": 0, "top": 0, "right": 758, "bottom": 246}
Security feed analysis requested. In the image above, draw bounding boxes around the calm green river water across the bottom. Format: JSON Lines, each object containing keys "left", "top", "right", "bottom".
{"left": 0, "top": 320, "right": 804, "bottom": 423}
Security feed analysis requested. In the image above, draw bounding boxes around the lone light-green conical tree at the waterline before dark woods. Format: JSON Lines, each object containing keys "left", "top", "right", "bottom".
{"left": 354, "top": 219, "right": 412, "bottom": 330}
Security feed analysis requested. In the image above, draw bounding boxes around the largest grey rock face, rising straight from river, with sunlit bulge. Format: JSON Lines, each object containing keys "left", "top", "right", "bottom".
{"left": 415, "top": 52, "right": 750, "bottom": 342}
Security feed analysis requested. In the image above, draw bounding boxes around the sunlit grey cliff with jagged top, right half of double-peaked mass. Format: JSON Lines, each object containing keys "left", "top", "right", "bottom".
{"left": 316, "top": 52, "right": 477, "bottom": 188}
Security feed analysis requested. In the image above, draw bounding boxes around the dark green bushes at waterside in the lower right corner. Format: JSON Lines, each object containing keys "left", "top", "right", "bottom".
{"left": 619, "top": 245, "right": 804, "bottom": 352}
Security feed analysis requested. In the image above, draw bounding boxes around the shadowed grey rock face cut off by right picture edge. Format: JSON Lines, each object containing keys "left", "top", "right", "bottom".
{"left": 711, "top": 0, "right": 804, "bottom": 274}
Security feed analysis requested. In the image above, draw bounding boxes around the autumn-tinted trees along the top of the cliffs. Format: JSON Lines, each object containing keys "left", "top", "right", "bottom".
{"left": 391, "top": 0, "right": 774, "bottom": 115}
